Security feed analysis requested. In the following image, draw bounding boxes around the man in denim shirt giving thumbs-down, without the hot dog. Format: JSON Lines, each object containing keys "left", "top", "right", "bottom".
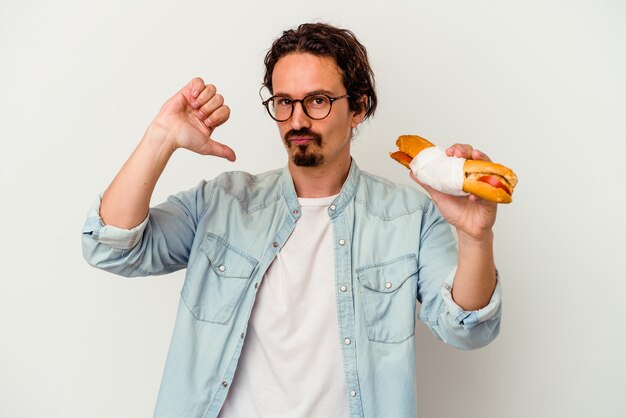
{"left": 83, "top": 24, "right": 500, "bottom": 418}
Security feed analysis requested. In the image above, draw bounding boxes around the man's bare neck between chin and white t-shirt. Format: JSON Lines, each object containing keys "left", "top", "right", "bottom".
{"left": 289, "top": 158, "right": 352, "bottom": 198}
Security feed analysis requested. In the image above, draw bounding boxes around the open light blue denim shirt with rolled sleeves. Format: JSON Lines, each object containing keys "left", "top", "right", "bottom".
{"left": 83, "top": 162, "right": 501, "bottom": 418}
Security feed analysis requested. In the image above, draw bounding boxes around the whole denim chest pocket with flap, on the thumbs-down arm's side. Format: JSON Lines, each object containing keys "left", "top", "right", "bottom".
{"left": 181, "top": 235, "right": 258, "bottom": 324}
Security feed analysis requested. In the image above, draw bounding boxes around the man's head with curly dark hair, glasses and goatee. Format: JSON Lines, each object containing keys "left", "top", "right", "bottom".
{"left": 264, "top": 23, "right": 376, "bottom": 170}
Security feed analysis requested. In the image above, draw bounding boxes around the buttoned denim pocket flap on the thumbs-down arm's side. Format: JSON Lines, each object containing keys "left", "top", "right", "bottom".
{"left": 200, "top": 234, "right": 257, "bottom": 279}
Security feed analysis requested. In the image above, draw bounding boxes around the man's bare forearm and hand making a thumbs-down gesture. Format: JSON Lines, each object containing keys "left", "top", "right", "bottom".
{"left": 100, "top": 78, "right": 235, "bottom": 229}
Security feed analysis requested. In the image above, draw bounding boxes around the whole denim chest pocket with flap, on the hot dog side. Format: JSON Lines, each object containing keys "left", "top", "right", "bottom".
{"left": 357, "top": 254, "right": 417, "bottom": 343}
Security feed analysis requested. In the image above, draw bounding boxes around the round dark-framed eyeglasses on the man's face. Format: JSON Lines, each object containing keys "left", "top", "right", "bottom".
{"left": 263, "top": 93, "right": 350, "bottom": 122}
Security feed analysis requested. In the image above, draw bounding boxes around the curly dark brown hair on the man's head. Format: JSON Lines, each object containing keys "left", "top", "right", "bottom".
{"left": 263, "top": 23, "right": 377, "bottom": 119}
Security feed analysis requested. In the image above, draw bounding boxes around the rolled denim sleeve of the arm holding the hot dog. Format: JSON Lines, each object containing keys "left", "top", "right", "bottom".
{"left": 418, "top": 199, "right": 502, "bottom": 350}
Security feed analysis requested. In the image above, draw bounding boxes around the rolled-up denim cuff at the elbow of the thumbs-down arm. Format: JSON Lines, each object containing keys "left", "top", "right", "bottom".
{"left": 83, "top": 196, "right": 148, "bottom": 250}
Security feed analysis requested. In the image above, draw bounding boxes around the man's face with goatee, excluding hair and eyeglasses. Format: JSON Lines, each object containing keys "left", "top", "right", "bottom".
{"left": 272, "top": 53, "right": 364, "bottom": 167}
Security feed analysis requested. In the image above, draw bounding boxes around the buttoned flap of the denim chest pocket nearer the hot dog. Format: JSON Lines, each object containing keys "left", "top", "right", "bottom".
{"left": 357, "top": 254, "right": 417, "bottom": 293}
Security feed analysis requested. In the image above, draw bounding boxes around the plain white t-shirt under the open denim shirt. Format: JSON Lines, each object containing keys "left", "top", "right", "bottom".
{"left": 219, "top": 196, "right": 349, "bottom": 418}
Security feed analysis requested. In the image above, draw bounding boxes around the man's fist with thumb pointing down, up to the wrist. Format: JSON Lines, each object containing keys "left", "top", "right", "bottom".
{"left": 148, "top": 78, "right": 235, "bottom": 161}
